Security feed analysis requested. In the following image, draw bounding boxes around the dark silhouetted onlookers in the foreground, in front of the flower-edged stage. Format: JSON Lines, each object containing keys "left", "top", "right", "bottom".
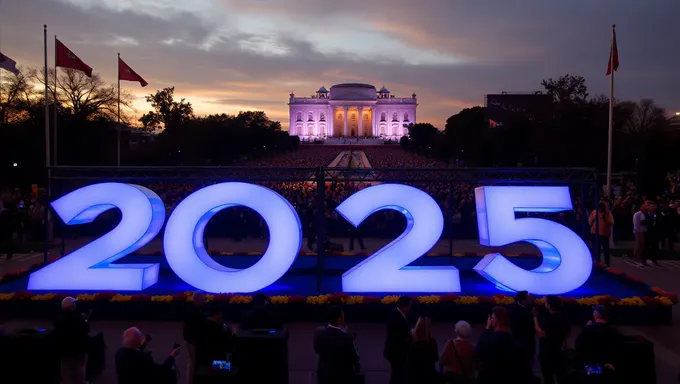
{"left": 54, "top": 291, "right": 625, "bottom": 384}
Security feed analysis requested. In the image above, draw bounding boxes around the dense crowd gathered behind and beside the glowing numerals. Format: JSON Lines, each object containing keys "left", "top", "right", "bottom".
{"left": 0, "top": 145, "right": 680, "bottom": 264}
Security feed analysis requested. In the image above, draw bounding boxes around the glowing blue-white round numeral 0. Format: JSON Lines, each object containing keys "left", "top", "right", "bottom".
{"left": 163, "top": 183, "right": 302, "bottom": 293}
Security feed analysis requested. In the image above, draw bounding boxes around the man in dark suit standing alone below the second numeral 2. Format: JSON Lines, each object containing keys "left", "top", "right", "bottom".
{"left": 314, "top": 306, "right": 359, "bottom": 384}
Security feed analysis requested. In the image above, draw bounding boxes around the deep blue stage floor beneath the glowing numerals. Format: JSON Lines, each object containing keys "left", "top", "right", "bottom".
{"left": 0, "top": 255, "right": 645, "bottom": 298}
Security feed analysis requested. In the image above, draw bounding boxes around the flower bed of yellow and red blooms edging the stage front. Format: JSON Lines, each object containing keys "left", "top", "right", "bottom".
{"left": 0, "top": 263, "right": 678, "bottom": 324}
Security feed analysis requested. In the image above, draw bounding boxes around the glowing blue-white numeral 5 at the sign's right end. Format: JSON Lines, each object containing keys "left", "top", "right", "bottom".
{"left": 474, "top": 187, "right": 593, "bottom": 295}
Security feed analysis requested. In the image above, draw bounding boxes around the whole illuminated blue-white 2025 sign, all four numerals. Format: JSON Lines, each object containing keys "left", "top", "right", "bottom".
{"left": 28, "top": 182, "right": 592, "bottom": 294}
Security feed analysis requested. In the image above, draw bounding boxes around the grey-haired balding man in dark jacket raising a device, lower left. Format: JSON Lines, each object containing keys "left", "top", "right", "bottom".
{"left": 115, "top": 327, "right": 180, "bottom": 384}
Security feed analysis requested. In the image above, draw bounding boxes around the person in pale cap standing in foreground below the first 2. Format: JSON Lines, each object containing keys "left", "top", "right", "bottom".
{"left": 54, "top": 296, "right": 90, "bottom": 384}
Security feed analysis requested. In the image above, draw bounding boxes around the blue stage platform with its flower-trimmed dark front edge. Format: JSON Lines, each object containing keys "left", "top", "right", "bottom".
{"left": 0, "top": 254, "right": 677, "bottom": 324}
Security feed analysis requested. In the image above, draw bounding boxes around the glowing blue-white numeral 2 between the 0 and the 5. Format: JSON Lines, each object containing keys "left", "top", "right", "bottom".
{"left": 336, "top": 184, "right": 460, "bottom": 292}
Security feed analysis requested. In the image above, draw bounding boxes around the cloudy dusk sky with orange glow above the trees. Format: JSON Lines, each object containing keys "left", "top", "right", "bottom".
{"left": 0, "top": 0, "right": 680, "bottom": 128}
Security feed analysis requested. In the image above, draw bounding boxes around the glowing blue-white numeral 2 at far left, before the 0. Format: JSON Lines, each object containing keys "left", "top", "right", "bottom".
{"left": 28, "top": 183, "right": 165, "bottom": 291}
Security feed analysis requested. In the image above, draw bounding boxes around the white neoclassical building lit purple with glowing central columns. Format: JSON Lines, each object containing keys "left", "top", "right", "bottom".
{"left": 288, "top": 83, "right": 418, "bottom": 139}
